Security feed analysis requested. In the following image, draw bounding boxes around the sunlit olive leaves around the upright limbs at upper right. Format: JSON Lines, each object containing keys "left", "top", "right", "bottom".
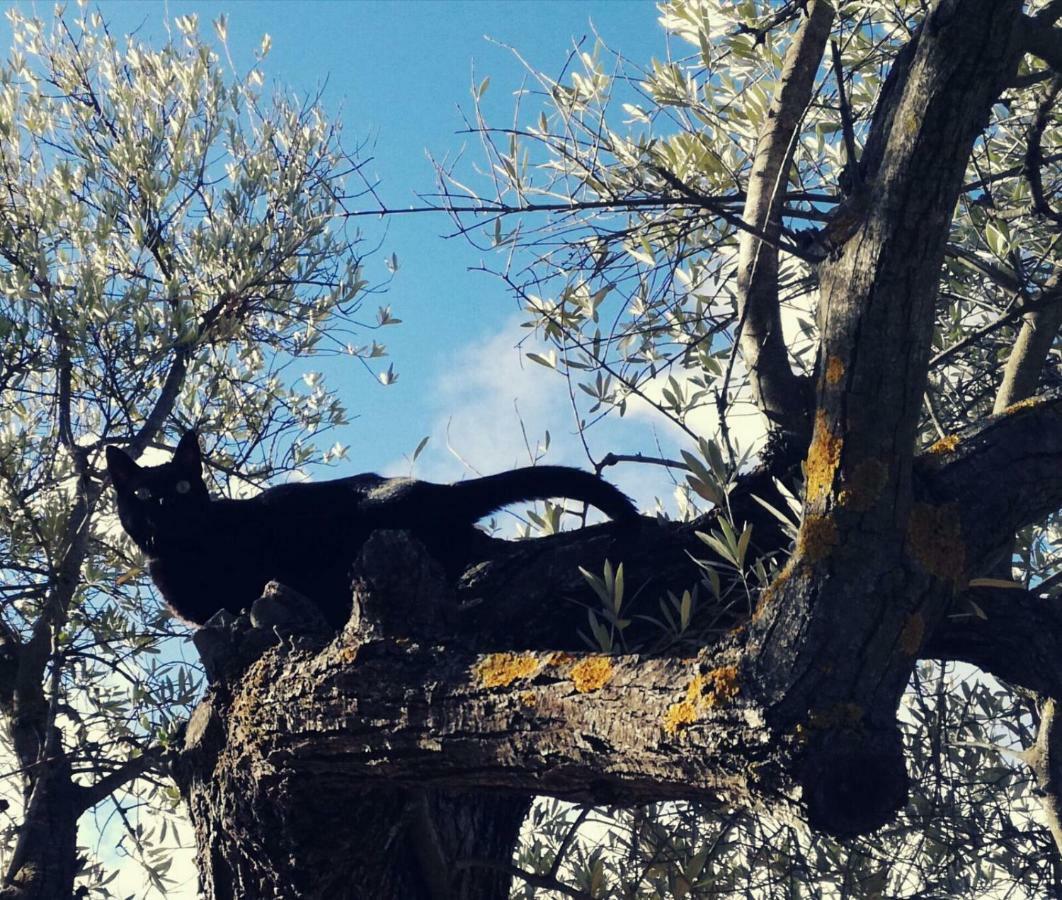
{"left": 440, "top": 0, "right": 1062, "bottom": 456}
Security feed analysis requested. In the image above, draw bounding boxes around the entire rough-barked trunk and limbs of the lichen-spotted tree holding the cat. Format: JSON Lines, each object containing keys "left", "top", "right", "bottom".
{"left": 177, "top": 0, "right": 1062, "bottom": 900}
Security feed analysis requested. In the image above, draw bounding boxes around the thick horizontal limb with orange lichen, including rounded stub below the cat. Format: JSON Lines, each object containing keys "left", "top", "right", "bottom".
{"left": 182, "top": 532, "right": 836, "bottom": 849}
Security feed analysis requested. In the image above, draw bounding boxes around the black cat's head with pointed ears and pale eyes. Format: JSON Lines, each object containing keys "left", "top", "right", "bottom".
{"left": 107, "top": 431, "right": 210, "bottom": 553}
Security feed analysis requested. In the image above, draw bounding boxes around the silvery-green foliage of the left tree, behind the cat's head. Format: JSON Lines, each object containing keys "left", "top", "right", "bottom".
{"left": 0, "top": 7, "right": 384, "bottom": 895}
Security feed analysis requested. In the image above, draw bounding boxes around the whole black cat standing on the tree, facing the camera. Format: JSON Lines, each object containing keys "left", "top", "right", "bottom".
{"left": 107, "top": 431, "right": 638, "bottom": 628}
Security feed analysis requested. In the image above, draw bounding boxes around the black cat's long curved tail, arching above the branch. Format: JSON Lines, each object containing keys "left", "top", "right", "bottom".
{"left": 447, "top": 465, "right": 638, "bottom": 522}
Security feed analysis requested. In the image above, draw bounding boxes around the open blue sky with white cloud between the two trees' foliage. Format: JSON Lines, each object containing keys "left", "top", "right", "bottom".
{"left": 38, "top": 0, "right": 705, "bottom": 502}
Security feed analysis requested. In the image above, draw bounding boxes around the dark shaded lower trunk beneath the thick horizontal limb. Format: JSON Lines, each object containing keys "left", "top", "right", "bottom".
{"left": 182, "top": 696, "right": 530, "bottom": 900}
